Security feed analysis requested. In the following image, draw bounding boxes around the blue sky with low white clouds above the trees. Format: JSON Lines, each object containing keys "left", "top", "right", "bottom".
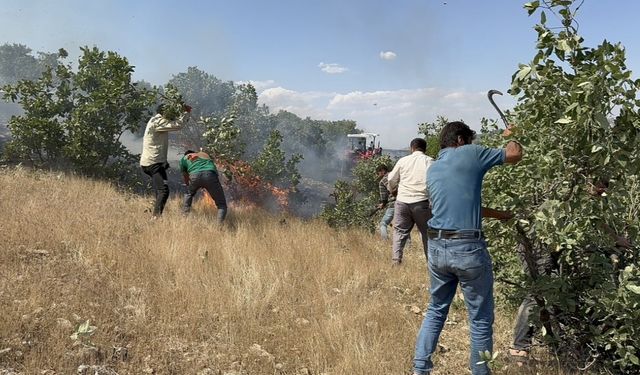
{"left": 0, "top": 0, "right": 640, "bottom": 148}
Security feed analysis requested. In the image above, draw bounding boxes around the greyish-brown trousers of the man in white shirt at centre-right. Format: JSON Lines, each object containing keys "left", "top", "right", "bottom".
{"left": 391, "top": 200, "right": 431, "bottom": 261}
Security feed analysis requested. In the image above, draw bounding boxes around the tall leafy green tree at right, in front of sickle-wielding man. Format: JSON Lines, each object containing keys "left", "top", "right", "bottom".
{"left": 483, "top": 0, "right": 640, "bottom": 374}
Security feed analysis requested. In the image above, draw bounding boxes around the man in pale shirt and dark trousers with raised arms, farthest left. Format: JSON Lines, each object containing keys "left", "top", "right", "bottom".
{"left": 140, "top": 104, "right": 191, "bottom": 218}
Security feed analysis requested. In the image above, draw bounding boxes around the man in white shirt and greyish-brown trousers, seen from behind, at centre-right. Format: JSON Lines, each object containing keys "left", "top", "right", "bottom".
{"left": 387, "top": 138, "right": 433, "bottom": 265}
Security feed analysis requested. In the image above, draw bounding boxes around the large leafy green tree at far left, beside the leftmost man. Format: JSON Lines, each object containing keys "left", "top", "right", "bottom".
{"left": 3, "top": 47, "right": 154, "bottom": 176}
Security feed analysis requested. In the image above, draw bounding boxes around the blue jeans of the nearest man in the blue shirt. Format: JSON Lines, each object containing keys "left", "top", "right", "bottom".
{"left": 414, "top": 239, "right": 494, "bottom": 375}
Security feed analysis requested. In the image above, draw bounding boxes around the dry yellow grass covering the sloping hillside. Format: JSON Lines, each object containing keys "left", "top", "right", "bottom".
{"left": 0, "top": 169, "right": 580, "bottom": 375}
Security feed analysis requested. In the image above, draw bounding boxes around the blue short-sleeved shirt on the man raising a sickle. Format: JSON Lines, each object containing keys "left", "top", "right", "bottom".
{"left": 427, "top": 144, "right": 506, "bottom": 230}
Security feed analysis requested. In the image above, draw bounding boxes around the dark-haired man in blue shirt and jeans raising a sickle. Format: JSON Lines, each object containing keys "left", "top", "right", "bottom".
{"left": 414, "top": 121, "right": 522, "bottom": 375}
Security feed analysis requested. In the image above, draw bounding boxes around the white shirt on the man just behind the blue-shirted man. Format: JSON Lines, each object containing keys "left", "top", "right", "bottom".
{"left": 388, "top": 151, "right": 433, "bottom": 203}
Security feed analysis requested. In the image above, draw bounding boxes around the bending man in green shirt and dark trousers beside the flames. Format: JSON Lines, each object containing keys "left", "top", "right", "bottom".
{"left": 180, "top": 150, "right": 227, "bottom": 223}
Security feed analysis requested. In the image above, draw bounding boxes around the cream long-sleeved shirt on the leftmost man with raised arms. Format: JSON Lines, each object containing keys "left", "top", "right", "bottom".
{"left": 140, "top": 113, "right": 189, "bottom": 167}
